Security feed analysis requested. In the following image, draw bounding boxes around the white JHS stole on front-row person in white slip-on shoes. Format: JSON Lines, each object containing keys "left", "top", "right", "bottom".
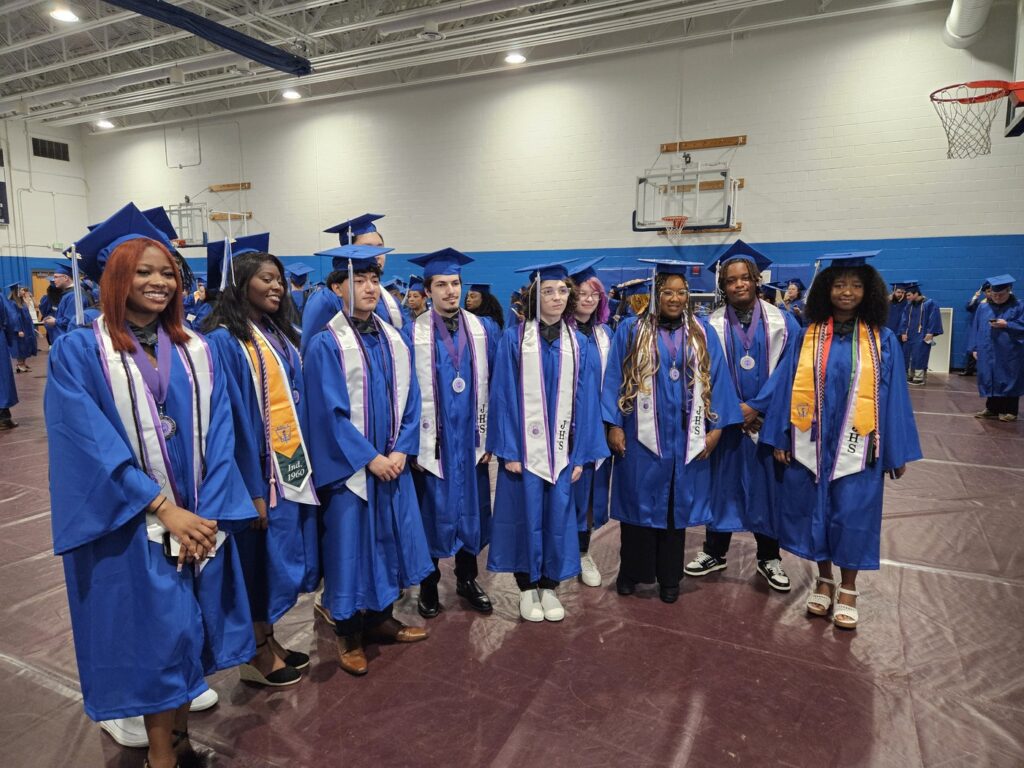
{"left": 519, "top": 321, "right": 580, "bottom": 484}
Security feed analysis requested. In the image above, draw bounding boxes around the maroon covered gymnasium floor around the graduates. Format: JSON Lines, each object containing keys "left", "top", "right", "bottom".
{"left": 0, "top": 355, "right": 1024, "bottom": 768}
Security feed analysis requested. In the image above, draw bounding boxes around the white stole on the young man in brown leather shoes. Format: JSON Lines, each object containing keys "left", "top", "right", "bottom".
{"left": 327, "top": 309, "right": 413, "bottom": 501}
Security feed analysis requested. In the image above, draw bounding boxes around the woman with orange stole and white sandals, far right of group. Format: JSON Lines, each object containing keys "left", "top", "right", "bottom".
{"left": 761, "top": 251, "right": 922, "bottom": 630}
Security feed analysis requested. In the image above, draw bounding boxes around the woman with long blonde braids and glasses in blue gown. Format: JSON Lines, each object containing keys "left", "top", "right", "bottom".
{"left": 601, "top": 260, "right": 743, "bottom": 603}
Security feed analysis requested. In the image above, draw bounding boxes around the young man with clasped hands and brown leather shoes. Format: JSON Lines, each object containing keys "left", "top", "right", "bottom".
{"left": 303, "top": 246, "right": 434, "bottom": 675}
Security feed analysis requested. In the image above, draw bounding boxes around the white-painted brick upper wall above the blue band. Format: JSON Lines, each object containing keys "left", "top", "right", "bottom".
{"left": 79, "top": 4, "right": 1024, "bottom": 254}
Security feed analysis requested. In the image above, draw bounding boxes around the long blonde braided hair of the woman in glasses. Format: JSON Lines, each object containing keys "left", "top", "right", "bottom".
{"left": 618, "top": 274, "right": 718, "bottom": 422}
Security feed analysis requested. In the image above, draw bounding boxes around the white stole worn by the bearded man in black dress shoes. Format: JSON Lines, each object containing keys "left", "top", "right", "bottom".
{"left": 413, "top": 309, "right": 489, "bottom": 479}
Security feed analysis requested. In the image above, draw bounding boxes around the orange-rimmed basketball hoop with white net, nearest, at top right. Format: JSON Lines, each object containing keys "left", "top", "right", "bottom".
{"left": 931, "top": 80, "right": 1024, "bottom": 160}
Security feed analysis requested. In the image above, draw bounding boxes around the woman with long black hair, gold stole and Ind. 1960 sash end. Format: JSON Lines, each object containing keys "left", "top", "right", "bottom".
{"left": 203, "top": 253, "right": 319, "bottom": 686}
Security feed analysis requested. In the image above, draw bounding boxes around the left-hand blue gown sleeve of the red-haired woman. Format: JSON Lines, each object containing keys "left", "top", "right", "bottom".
{"left": 43, "top": 332, "right": 160, "bottom": 555}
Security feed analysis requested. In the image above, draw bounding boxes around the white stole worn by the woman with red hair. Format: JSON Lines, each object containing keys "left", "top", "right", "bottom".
{"left": 92, "top": 315, "right": 226, "bottom": 557}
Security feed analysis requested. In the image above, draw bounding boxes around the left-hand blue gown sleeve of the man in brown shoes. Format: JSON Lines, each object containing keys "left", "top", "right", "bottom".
{"left": 302, "top": 329, "right": 379, "bottom": 487}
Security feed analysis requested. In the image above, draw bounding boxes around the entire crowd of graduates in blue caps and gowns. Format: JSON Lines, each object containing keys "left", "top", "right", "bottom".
{"left": 0, "top": 199, "right": 1024, "bottom": 768}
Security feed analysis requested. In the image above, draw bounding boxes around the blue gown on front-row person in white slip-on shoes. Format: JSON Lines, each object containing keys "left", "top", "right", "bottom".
{"left": 487, "top": 326, "right": 608, "bottom": 582}
